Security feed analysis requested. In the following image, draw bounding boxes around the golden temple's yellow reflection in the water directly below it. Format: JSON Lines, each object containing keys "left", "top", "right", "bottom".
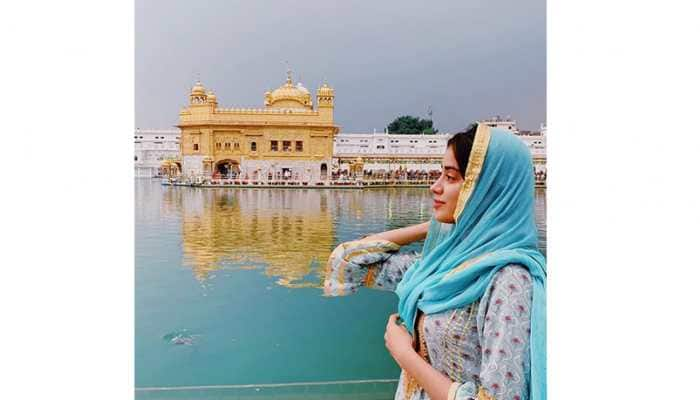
{"left": 175, "top": 189, "right": 334, "bottom": 287}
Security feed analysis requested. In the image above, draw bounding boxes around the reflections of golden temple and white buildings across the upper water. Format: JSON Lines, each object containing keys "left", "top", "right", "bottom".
{"left": 160, "top": 187, "right": 546, "bottom": 287}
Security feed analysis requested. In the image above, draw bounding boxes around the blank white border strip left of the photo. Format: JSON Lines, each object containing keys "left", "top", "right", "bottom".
{"left": 0, "top": 1, "right": 134, "bottom": 399}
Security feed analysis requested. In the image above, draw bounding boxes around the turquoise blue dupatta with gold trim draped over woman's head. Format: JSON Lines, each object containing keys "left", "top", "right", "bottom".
{"left": 396, "top": 124, "right": 547, "bottom": 400}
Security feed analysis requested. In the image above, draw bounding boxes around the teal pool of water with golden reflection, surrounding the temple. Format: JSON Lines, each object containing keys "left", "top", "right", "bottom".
{"left": 135, "top": 180, "right": 546, "bottom": 399}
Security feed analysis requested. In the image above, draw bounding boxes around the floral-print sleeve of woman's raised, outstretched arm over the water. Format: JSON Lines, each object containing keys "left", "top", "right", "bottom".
{"left": 323, "top": 239, "right": 420, "bottom": 296}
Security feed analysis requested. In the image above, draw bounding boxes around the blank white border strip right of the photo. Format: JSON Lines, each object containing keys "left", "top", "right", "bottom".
{"left": 547, "top": 0, "right": 700, "bottom": 399}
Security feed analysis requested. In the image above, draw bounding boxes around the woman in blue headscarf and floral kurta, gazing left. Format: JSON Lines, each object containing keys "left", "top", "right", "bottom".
{"left": 325, "top": 124, "right": 546, "bottom": 400}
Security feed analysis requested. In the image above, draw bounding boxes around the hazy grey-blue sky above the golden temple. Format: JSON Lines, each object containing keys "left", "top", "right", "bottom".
{"left": 135, "top": 0, "right": 546, "bottom": 133}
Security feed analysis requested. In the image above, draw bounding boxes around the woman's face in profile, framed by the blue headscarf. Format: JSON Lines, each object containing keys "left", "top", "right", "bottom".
{"left": 430, "top": 146, "right": 464, "bottom": 224}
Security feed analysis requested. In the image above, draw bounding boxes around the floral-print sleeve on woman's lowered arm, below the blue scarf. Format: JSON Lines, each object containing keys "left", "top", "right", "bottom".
{"left": 456, "top": 265, "right": 532, "bottom": 400}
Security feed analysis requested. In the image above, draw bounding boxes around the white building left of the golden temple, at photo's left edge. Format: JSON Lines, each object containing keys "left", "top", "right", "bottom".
{"left": 134, "top": 129, "right": 180, "bottom": 178}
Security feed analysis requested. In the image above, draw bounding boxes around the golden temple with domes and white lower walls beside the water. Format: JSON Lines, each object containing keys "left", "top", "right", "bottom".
{"left": 177, "top": 71, "right": 339, "bottom": 180}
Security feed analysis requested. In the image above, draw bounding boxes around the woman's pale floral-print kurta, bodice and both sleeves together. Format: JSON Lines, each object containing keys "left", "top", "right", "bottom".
{"left": 324, "top": 241, "right": 532, "bottom": 400}
